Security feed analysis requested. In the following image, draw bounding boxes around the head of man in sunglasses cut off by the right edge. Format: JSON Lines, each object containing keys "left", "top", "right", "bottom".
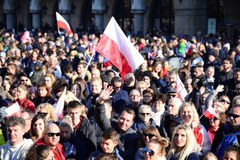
{"left": 227, "top": 105, "right": 240, "bottom": 126}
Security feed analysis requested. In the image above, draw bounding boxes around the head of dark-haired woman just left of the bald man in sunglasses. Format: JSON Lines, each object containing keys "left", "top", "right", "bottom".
{"left": 30, "top": 114, "right": 48, "bottom": 138}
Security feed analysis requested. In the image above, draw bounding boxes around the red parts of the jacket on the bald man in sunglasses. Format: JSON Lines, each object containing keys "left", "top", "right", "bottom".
{"left": 35, "top": 138, "right": 66, "bottom": 160}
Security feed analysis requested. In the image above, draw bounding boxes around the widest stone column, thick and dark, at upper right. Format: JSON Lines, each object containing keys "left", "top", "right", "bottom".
{"left": 173, "top": 0, "right": 207, "bottom": 36}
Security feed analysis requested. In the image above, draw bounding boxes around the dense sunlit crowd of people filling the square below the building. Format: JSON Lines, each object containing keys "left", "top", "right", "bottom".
{"left": 0, "top": 26, "right": 240, "bottom": 160}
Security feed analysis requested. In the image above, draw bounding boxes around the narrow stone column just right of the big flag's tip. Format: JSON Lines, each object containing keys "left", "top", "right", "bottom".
{"left": 131, "top": 0, "right": 146, "bottom": 34}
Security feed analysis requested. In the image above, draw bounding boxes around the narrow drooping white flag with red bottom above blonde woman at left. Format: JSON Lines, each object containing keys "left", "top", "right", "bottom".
{"left": 53, "top": 87, "right": 66, "bottom": 119}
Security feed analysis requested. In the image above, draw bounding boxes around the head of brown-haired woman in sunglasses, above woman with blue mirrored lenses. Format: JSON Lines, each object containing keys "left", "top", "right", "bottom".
{"left": 142, "top": 126, "right": 161, "bottom": 145}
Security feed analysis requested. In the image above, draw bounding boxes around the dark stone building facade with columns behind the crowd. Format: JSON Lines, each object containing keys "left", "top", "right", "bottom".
{"left": 0, "top": 0, "right": 240, "bottom": 36}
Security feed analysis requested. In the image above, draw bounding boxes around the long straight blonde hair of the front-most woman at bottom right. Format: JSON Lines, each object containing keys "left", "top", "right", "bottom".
{"left": 167, "top": 124, "right": 198, "bottom": 160}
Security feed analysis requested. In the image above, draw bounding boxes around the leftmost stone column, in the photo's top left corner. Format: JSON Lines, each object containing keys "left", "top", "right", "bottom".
{"left": 3, "top": 0, "right": 15, "bottom": 30}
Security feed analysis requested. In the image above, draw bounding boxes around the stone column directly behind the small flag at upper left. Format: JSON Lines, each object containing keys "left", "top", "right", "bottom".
{"left": 58, "top": 0, "right": 72, "bottom": 22}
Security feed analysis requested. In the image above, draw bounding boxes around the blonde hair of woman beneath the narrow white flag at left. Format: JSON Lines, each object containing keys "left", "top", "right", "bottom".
{"left": 35, "top": 103, "right": 58, "bottom": 122}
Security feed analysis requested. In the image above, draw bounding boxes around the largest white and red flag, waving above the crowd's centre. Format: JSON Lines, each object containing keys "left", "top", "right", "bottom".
{"left": 96, "top": 17, "right": 144, "bottom": 79}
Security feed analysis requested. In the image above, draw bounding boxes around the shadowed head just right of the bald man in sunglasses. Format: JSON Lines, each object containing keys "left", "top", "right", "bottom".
{"left": 59, "top": 122, "right": 73, "bottom": 141}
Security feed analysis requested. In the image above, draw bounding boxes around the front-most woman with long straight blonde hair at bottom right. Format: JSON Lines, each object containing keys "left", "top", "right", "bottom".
{"left": 167, "top": 124, "right": 199, "bottom": 160}
